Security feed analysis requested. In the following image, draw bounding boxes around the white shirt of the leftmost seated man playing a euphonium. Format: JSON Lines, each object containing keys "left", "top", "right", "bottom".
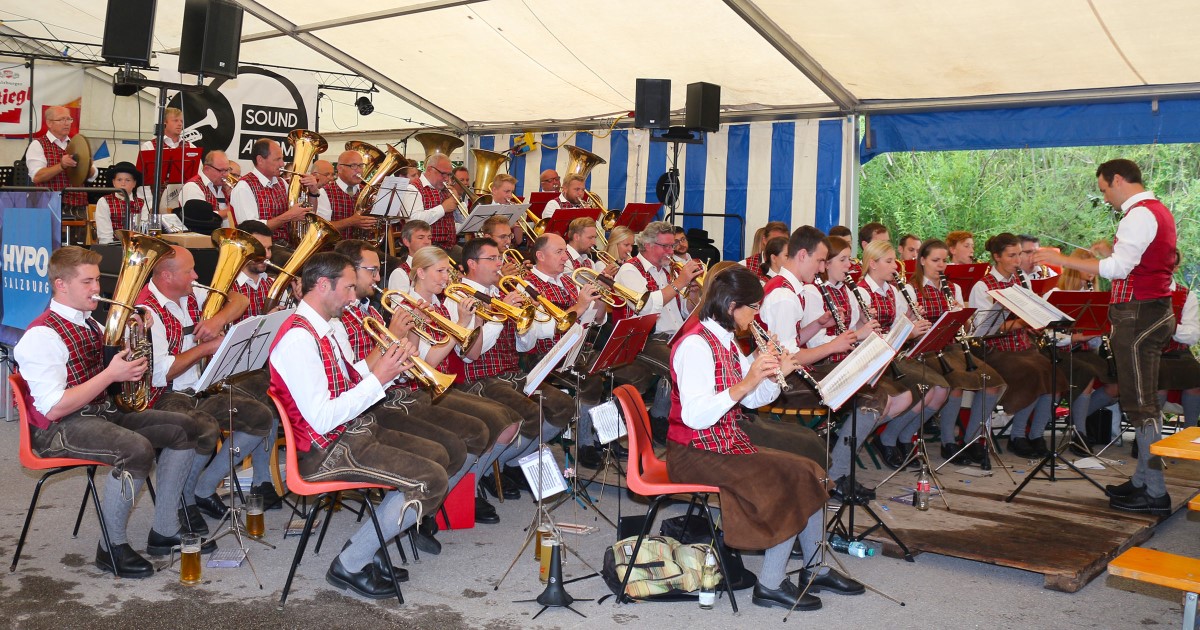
{"left": 13, "top": 299, "right": 102, "bottom": 415}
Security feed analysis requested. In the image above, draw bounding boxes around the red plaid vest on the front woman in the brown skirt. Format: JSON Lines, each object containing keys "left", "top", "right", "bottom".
{"left": 667, "top": 325, "right": 758, "bottom": 455}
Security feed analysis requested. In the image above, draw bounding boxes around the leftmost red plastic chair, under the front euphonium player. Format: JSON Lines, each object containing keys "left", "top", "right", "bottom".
{"left": 8, "top": 372, "right": 116, "bottom": 572}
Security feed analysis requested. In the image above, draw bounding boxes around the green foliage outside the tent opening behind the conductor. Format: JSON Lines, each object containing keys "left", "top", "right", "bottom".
{"left": 859, "top": 144, "right": 1200, "bottom": 284}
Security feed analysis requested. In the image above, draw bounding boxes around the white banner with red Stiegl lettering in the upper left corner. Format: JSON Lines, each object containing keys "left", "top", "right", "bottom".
{"left": 0, "top": 60, "right": 83, "bottom": 138}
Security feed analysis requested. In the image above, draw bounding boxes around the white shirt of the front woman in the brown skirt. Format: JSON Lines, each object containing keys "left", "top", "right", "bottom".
{"left": 671, "top": 319, "right": 780, "bottom": 431}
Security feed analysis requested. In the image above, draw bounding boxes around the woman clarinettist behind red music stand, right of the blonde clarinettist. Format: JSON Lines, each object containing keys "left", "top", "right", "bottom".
{"left": 912, "top": 239, "right": 1004, "bottom": 468}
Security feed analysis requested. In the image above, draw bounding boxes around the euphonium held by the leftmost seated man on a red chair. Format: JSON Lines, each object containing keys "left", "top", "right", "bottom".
{"left": 101, "top": 229, "right": 173, "bottom": 412}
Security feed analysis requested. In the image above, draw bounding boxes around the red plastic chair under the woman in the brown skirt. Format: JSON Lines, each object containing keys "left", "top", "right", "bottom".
{"left": 612, "top": 385, "right": 738, "bottom": 612}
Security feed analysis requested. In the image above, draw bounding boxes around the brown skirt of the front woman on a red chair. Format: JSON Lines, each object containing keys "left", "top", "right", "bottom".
{"left": 666, "top": 440, "right": 829, "bottom": 550}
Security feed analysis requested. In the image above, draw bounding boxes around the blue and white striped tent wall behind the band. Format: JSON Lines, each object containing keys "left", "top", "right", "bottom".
{"left": 472, "top": 119, "right": 854, "bottom": 259}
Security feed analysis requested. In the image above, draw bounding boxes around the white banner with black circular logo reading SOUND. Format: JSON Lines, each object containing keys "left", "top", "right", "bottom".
{"left": 163, "top": 61, "right": 317, "bottom": 168}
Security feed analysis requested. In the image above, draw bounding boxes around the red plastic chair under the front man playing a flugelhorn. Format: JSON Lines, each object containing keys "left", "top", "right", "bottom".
{"left": 268, "top": 391, "right": 404, "bottom": 610}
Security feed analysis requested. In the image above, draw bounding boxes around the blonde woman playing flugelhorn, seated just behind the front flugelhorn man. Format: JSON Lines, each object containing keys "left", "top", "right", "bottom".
{"left": 405, "top": 246, "right": 521, "bottom": 513}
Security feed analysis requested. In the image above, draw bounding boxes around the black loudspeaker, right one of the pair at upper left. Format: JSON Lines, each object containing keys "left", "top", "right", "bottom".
{"left": 179, "top": 0, "right": 242, "bottom": 79}
